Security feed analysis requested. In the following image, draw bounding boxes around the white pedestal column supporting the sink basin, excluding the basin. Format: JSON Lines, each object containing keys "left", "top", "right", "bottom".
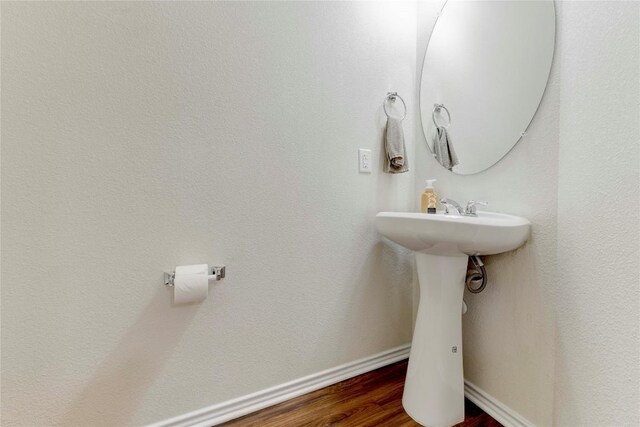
{"left": 402, "top": 252, "right": 468, "bottom": 427}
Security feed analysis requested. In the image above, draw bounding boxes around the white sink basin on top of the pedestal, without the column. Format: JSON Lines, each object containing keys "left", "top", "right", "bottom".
{"left": 376, "top": 212, "right": 530, "bottom": 255}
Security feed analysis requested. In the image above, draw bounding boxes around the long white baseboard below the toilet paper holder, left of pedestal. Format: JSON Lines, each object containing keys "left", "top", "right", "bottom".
{"left": 149, "top": 344, "right": 411, "bottom": 427}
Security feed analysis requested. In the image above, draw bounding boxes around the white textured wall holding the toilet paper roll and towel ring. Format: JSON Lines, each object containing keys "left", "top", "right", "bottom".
{"left": 2, "top": 2, "right": 415, "bottom": 426}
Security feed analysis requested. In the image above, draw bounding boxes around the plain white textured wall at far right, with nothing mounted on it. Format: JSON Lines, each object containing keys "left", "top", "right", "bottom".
{"left": 555, "top": 2, "right": 640, "bottom": 426}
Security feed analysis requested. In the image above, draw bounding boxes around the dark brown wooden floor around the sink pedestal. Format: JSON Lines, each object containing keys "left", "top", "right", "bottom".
{"left": 222, "top": 361, "right": 502, "bottom": 427}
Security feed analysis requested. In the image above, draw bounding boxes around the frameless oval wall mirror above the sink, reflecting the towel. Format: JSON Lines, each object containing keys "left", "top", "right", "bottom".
{"left": 420, "top": 0, "right": 555, "bottom": 175}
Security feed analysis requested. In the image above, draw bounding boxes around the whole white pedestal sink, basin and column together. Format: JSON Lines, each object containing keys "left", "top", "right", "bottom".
{"left": 376, "top": 212, "right": 531, "bottom": 427}
